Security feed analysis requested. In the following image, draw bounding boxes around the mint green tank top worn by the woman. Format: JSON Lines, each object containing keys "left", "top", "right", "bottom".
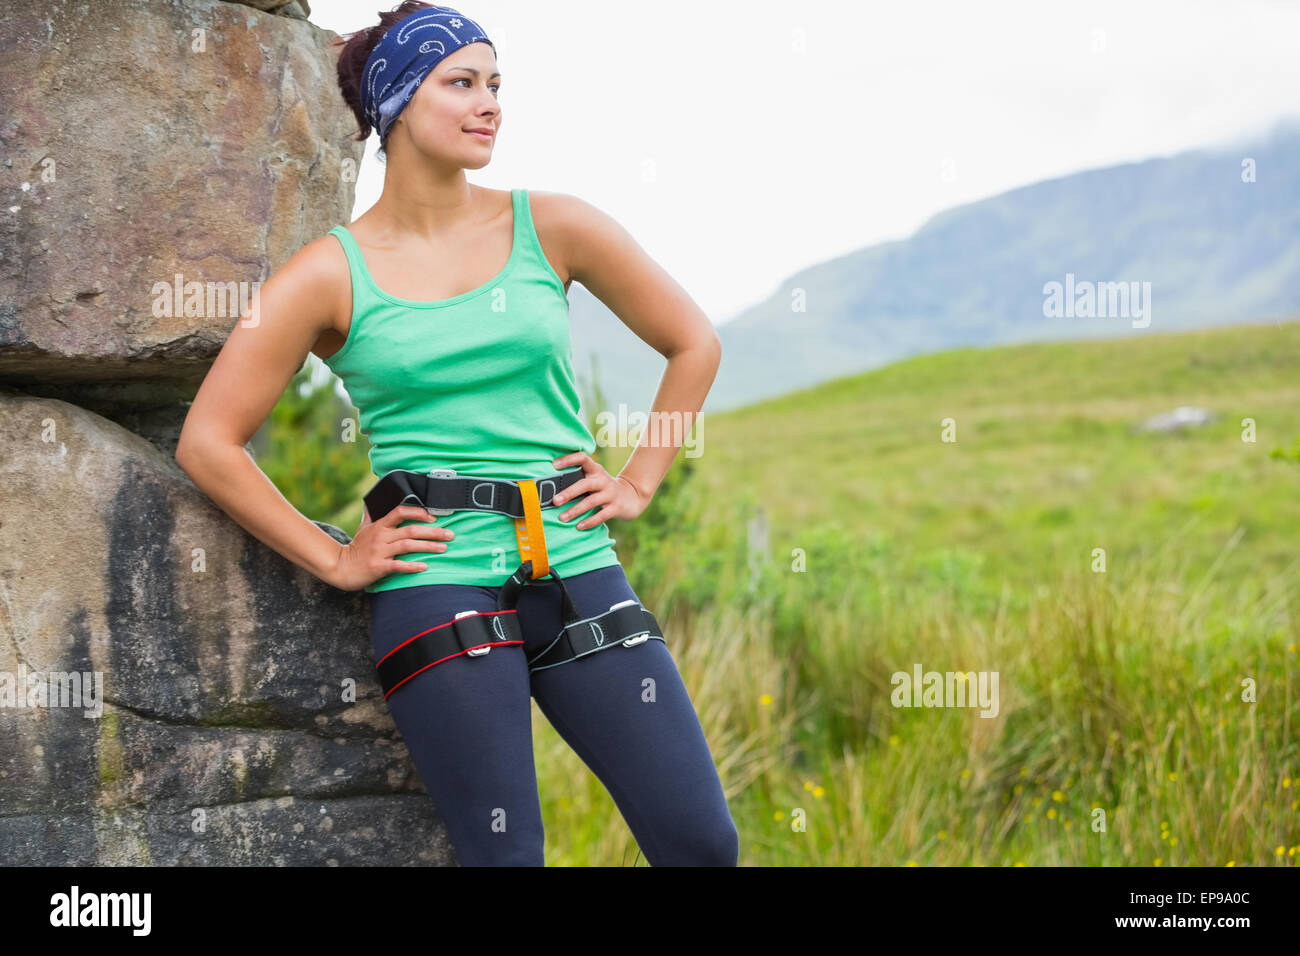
{"left": 324, "top": 189, "right": 619, "bottom": 592}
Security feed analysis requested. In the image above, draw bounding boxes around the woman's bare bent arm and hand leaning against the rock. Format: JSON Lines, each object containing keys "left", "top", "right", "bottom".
{"left": 176, "top": 235, "right": 452, "bottom": 591}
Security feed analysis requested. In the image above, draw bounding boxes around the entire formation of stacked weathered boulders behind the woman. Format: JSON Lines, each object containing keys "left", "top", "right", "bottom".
{"left": 0, "top": 0, "right": 455, "bottom": 865}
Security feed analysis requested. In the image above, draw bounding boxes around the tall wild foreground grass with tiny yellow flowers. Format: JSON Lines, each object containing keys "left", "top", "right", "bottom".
{"left": 534, "top": 502, "right": 1300, "bottom": 866}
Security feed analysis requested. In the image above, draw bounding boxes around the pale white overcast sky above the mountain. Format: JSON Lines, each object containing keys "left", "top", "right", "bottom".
{"left": 311, "top": 0, "right": 1300, "bottom": 324}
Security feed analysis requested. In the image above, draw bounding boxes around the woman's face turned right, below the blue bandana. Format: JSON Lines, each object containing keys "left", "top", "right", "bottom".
{"left": 394, "top": 42, "right": 501, "bottom": 169}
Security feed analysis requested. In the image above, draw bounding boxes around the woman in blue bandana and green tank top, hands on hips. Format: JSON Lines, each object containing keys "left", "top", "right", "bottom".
{"left": 177, "top": 1, "right": 738, "bottom": 866}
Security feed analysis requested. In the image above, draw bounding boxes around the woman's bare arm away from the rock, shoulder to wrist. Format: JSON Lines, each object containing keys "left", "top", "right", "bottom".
{"left": 537, "top": 193, "right": 722, "bottom": 509}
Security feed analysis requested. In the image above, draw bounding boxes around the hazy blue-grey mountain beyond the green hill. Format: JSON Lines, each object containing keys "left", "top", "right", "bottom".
{"left": 569, "top": 122, "right": 1300, "bottom": 411}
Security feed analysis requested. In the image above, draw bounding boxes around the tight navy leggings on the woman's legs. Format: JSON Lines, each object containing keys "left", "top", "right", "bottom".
{"left": 371, "top": 564, "right": 740, "bottom": 866}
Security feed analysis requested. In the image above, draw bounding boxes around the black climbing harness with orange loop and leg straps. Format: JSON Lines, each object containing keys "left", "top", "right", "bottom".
{"left": 365, "top": 468, "right": 667, "bottom": 698}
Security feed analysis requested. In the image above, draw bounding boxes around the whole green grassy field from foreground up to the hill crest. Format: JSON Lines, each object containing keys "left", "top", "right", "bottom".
{"left": 533, "top": 323, "right": 1300, "bottom": 866}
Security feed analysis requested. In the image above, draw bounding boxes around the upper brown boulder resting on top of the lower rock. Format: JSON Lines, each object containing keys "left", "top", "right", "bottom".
{"left": 0, "top": 0, "right": 351, "bottom": 450}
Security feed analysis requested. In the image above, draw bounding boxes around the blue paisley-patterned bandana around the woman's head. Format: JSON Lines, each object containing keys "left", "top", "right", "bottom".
{"left": 361, "top": 7, "right": 497, "bottom": 143}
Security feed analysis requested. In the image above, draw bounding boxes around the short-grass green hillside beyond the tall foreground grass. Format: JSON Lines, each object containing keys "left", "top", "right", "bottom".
{"left": 698, "top": 323, "right": 1300, "bottom": 608}
